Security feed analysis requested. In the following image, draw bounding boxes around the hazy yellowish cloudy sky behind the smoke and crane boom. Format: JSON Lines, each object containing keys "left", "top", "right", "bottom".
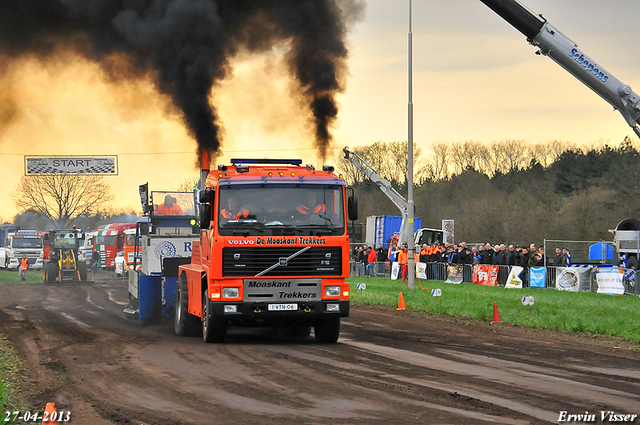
{"left": 0, "top": 0, "right": 640, "bottom": 221}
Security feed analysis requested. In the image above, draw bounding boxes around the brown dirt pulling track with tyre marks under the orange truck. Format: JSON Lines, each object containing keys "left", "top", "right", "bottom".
{"left": 0, "top": 281, "right": 640, "bottom": 425}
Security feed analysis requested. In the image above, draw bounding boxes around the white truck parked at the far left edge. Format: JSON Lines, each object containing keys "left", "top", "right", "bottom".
{"left": 0, "top": 230, "right": 44, "bottom": 270}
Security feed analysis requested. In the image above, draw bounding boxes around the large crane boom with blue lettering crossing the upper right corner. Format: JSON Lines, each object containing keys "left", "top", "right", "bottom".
{"left": 480, "top": 0, "right": 640, "bottom": 137}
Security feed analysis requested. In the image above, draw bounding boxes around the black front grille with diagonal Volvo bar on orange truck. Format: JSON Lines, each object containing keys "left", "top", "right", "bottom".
{"left": 222, "top": 247, "right": 342, "bottom": 277}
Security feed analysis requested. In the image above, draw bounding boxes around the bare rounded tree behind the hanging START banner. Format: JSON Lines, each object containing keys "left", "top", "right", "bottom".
{"left": 10, "top": 174, "right": 113, "bottom": 228}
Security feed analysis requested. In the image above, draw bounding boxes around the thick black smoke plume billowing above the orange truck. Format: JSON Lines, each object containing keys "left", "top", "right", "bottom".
{"left": 0, "top": 0, "right": 363, "bottom": 159}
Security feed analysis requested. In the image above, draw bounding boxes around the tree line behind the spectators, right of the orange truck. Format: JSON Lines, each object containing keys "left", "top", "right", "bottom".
{"left": 339, "top": 137, "right": 640, "bottom": 244}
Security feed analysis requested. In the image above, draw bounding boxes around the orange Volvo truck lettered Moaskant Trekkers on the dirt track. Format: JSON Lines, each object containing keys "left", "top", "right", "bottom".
{"left": 175, "top": 157, "right": 357, "bottom": 343}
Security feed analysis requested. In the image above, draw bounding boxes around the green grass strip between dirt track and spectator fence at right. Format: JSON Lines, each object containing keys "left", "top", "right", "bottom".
{"left": 347, "top": 277, "right": 640, "bottom": 343}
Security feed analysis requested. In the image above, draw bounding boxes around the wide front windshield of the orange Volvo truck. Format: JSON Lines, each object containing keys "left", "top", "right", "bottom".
{"left": 218, "top": 185, "right": 345, "bottom": 236}
